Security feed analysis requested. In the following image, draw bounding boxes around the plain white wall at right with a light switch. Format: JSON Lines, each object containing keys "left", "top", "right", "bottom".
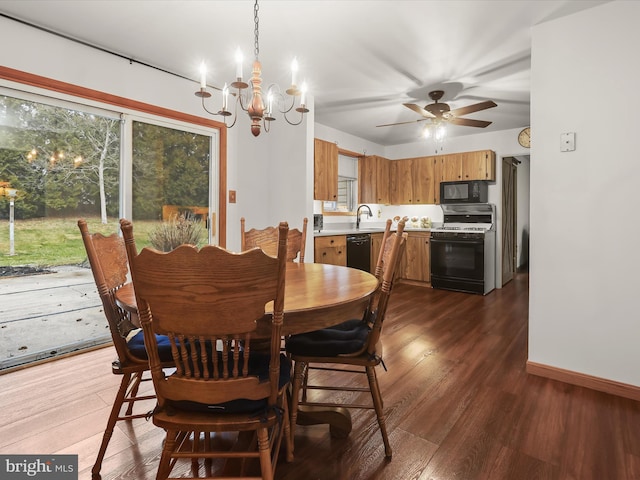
{"left": 529, "top": 1, "right": 640, "bottom": 386}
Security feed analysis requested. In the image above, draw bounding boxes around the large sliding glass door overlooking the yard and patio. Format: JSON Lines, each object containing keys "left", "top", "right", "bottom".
{"left": 0, "top": 89, "right": 219, "bottom": 371}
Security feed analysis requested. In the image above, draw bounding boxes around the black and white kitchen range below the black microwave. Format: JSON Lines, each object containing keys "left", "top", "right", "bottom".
{"left": 430, "top": 204, "right": 495, "bottom": 295}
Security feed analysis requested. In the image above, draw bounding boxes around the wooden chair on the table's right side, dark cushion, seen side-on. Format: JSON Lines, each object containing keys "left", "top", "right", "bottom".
{"left": 286, "top": 221, "right": 407, "bottom": 457}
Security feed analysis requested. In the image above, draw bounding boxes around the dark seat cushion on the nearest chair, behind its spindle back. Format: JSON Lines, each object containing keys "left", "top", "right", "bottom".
{"left": 168, "top": 353, "right": 291, "bottom": 413}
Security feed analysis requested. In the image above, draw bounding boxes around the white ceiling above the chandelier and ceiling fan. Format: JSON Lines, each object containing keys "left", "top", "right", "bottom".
{"left": 0, "top": 0, "right": 608, "bottom": 145}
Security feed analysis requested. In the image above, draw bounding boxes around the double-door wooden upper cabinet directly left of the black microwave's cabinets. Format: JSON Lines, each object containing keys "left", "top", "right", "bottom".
{"left": 389, "top": 157, "right": 436, "bottom": 205}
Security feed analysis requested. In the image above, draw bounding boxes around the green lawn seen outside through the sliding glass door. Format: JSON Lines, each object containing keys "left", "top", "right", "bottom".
{"left": 0, "top": 217, "right": 160, "bottom": 267}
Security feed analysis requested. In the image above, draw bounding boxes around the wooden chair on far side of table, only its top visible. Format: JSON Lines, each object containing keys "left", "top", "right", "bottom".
{"left": 240, "top": 217, "right": 308, "bottom": 263}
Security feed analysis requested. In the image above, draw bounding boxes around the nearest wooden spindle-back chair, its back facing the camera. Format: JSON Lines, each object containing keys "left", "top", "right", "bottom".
{"left": 120, "top": 219, "right": 291, "bottom": 480}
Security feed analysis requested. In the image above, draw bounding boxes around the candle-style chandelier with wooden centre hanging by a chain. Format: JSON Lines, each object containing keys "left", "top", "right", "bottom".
{"left": 196, "top": 0, "right": 309, "bottom": 137}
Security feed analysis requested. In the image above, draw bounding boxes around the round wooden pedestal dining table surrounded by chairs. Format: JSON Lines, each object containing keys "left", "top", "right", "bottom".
{"left": 116, "top": 262, "right": 378, "bottom": 437}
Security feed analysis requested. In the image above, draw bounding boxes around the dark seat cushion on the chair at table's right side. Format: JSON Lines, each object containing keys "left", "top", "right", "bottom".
{"left": 286, "top": 319, "right": 370, "bottom": 357}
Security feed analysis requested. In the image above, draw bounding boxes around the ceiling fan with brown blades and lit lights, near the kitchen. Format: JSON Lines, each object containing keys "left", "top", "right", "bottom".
{"left": 377, "top": 90, "right": 498, "bottom": 128}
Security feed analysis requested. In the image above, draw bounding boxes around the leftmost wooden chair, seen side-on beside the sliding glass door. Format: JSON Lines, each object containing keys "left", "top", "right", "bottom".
{"left": 78, "top": 219, "right": 171, "bottom": 478}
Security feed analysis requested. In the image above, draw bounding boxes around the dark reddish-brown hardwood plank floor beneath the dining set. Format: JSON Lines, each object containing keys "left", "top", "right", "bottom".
{"left": 0, "top": 274, "right": 640, "bottom": 480}
